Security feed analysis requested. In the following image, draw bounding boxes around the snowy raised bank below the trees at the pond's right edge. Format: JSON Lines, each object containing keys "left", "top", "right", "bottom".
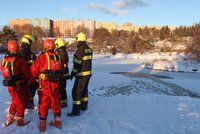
{"left": 133, "top": 53, "right": 200, "bottom": 73}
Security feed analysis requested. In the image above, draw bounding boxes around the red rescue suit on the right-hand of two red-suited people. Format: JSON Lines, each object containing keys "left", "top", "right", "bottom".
{"left": 31, "top": 52, "right": 62, "bottom": 120}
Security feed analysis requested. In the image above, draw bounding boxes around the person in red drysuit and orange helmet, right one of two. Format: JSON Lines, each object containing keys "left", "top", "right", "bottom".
{"left": 31, "top": 39, "right": 62, "bottom": 132}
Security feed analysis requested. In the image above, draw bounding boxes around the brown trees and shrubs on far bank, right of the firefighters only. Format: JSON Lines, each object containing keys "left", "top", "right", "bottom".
{"left": 92, "top": 24, "right": 200, "bottom": 57}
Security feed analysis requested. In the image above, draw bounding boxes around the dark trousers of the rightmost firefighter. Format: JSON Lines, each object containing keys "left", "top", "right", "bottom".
{"left": 72, "top": 77, "right": 90, "bottom": 102}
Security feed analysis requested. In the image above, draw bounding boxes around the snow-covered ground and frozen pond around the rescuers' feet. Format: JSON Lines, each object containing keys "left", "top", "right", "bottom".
{"left": 0, "top": 54, "right": 200, "bottom": 134}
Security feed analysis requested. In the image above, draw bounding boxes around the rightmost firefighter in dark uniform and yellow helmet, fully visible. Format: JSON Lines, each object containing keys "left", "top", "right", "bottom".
{"left": 68, "top": 33, "right": 92, "bottom": 116}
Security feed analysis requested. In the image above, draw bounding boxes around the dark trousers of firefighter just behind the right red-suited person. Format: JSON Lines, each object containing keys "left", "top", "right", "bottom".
{"left": 59, "top": 80, "right": 67, "bottom": 103}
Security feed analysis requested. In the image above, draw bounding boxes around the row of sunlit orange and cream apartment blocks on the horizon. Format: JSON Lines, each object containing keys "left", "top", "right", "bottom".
{"left": 9, "top": 19, "right": 176, "bottom": 38}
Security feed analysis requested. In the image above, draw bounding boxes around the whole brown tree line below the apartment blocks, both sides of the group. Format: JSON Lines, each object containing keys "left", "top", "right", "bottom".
{"left": 1, "top": 24, "right": 200, "bottom": 59}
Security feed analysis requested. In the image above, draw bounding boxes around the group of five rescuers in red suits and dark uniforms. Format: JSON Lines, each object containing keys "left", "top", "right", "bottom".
{"left": 1, "top": 33, "right": 93, "bottom": 132}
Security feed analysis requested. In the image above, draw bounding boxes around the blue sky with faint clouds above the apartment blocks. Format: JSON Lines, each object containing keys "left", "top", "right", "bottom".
{"left": 0, "top": 0, "right": 200, "bottom": 26}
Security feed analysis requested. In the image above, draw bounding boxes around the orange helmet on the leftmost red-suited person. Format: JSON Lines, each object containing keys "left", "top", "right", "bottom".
{"left": 7, "top": 40, "right": 19, "bottom": 54}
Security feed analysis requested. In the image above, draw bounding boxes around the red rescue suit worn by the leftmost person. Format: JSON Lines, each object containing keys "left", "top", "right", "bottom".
{"left": 1, "top": 56, "right": 34, "bottom": 117}
